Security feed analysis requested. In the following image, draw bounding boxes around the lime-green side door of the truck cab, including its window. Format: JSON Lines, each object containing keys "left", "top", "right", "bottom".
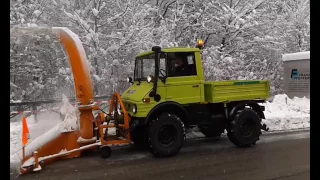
{"left": 165, "top": 52, "right": 201, "bottom": 104}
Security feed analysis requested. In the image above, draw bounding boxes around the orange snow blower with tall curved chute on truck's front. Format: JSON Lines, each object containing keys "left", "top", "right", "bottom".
{"left": 20, "top": 27, "right": 131, "bottom": 174}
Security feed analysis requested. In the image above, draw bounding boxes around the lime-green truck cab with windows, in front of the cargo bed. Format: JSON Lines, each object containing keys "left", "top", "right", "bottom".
{"left": 122, "top": 48, "right": 204, "bottom": 104}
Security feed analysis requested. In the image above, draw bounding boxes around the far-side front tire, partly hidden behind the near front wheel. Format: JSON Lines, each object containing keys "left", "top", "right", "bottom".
{"left": 130, "top": 126, "right": 148, "bottom": 148}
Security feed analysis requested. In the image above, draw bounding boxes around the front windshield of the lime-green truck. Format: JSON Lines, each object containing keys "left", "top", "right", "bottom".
{"left": 134, "top": 54, "right": 155, "bottom": 81}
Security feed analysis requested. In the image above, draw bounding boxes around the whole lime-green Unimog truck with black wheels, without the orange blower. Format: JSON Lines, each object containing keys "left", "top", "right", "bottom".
{"left": 121, "top": 41, "right": 270, "bottom": 157}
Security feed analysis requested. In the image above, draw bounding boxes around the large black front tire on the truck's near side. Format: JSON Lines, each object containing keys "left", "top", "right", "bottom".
{"left": 148, "top": 113, "right": 186, "bottom": 157}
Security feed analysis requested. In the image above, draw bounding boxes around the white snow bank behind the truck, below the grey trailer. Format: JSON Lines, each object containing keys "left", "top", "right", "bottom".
{"left": 263, "top": 94, "right": 310, "bottom": 131}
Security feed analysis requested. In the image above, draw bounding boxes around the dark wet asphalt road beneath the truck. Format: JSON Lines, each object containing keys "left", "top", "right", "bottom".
{"left": 10, "top": 131, "right": 310, "bottom": 180}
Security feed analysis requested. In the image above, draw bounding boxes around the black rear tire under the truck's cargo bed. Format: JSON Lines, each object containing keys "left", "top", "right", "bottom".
{"left": 227, "top": 108, "right": 261, "bottom": 147}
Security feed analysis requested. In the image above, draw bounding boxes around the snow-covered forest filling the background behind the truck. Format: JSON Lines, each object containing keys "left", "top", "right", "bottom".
{"left": 10, "top": 0, "right": 310, "bottom": 101}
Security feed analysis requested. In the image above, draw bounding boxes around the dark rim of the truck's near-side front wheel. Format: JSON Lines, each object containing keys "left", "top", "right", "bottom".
{"left": 158, "top": 125, "right": 177, "bottom": 146}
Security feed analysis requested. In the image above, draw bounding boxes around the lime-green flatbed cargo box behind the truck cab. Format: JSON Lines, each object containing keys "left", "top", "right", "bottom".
{"left": 204, "top": 80, "right": 270, "bottom": 103}
